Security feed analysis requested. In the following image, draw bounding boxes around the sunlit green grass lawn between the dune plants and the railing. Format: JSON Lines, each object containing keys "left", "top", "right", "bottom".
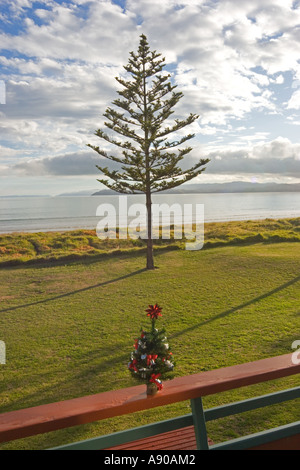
{"left": 0, "top": 227, "right": 300, "bottom": 449}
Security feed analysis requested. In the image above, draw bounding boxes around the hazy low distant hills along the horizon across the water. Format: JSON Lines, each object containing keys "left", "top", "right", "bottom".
{"left": 92, "top": 181, "right": 300, "bottom": 196}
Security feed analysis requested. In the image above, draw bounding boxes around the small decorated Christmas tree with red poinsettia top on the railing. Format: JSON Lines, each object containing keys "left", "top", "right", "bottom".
{"left": 128, "top": 304, "right": 174, "bottom": 394}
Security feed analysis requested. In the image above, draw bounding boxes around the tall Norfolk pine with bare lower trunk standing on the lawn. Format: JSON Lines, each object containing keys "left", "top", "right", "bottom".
{"left": 88, "top": 35, "right": 209, "bottom": 269}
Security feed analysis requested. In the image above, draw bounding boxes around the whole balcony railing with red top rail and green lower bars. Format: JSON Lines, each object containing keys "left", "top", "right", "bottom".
{"left": 0, "top": 354, "right": 300, "bottom": 450}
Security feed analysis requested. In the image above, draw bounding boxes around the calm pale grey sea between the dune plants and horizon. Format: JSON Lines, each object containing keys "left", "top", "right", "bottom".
{"left": 0, "top": 192, "right": 300, "bottom": 234}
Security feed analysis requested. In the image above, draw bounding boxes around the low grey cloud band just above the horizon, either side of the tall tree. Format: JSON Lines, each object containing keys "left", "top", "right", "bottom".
{"left": 5, "top": 138, "right": 300, "bottom": 180}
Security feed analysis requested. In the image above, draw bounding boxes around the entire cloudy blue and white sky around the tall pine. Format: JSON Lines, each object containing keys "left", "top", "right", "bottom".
{"left": 0, "top": 0, "right": 300, "bottom": 196}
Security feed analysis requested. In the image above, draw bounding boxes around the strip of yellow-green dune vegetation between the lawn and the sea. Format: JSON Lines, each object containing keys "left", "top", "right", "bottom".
{"left": 0, "top": 218, "right": 300, "bottom": 267}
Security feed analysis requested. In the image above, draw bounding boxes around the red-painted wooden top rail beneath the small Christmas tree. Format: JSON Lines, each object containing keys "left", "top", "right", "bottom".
{"left": 0, "top": 354, "right": 300, "bottom": 450}
